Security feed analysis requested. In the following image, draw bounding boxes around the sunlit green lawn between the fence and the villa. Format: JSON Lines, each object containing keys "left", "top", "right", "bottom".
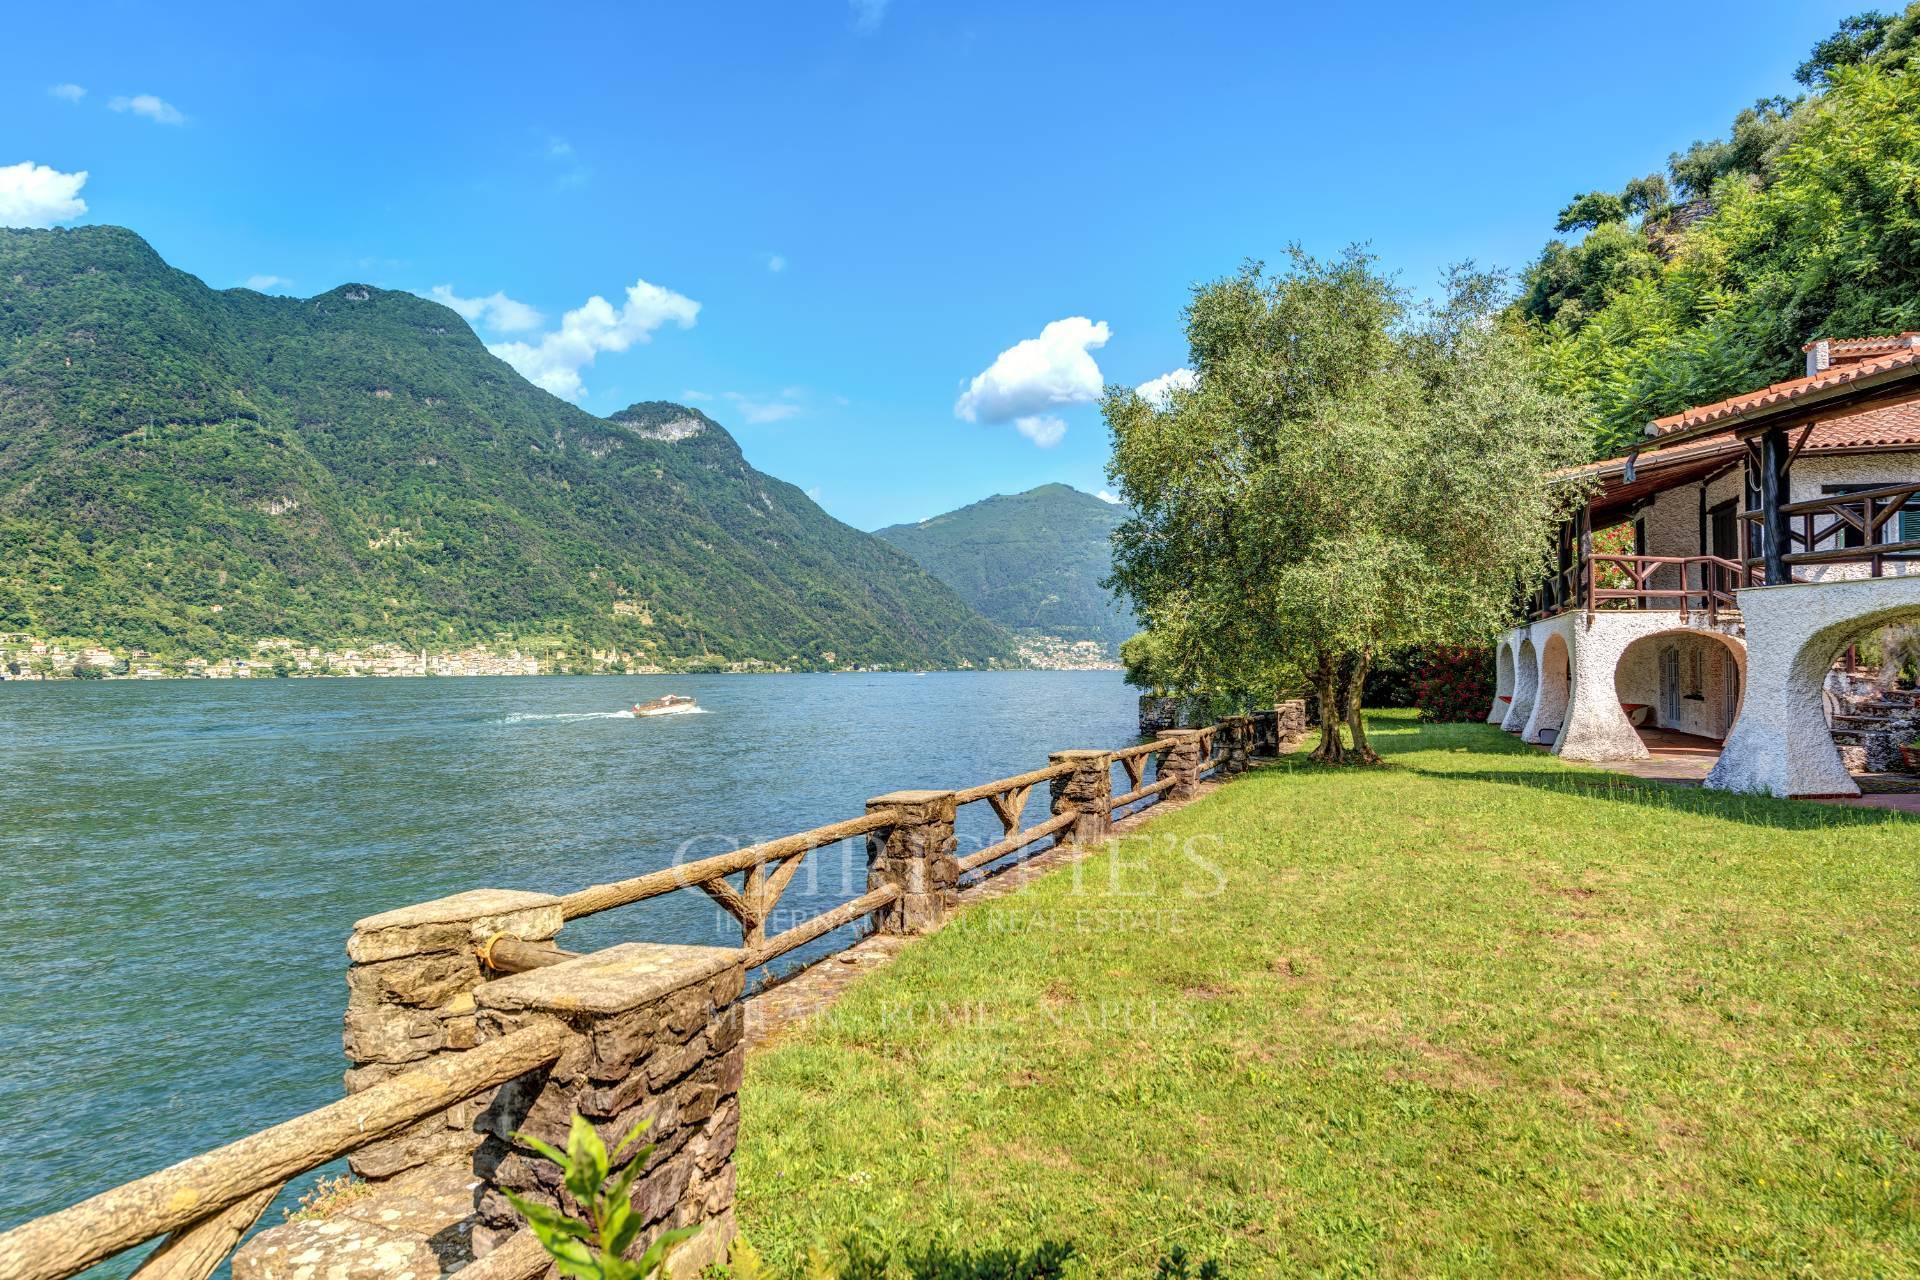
{"left": 739, "top": 716, "right": 1920, "bottom": 1278}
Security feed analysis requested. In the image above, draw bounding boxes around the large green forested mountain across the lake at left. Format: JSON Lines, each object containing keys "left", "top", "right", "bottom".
{"left": 0, "top": 226, "right": 1010, "bottom": 666}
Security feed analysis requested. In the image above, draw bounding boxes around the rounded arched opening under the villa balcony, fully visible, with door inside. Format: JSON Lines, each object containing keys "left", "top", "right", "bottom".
{"left": 1613, "top": 629, "right": 1747, "bottom": 756}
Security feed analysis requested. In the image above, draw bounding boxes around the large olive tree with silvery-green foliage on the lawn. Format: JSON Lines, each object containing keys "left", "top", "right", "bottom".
{"left": 1102, "top": 249, "right": 1584, "bottom": 762}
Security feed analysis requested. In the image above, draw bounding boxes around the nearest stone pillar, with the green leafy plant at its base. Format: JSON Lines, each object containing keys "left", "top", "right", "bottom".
{"left": 474, "top": 942, "right": 747, "bottom": 1280}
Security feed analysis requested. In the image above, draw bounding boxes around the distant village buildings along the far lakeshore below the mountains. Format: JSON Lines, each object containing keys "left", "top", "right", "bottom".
{"left": 0, "top": 631, "right": 1119, "bottom": 679}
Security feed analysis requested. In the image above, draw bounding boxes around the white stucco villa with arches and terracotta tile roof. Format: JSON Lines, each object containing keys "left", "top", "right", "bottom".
{"left": 1488, "top": 332, "right": 1920, "bottom": 796}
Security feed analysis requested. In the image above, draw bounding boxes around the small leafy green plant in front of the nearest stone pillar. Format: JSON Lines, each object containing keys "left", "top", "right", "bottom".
{"left": 507, "top": 1113, "right": 699, "bottom": 1280}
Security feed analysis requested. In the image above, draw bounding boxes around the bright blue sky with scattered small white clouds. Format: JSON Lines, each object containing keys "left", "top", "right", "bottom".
{"left": 0, "top": 0, "right": 1862, "bottom": 528}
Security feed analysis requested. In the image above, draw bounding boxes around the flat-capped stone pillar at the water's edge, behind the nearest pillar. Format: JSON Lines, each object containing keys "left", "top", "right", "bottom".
{"left": 342, "top": 889, "right": 561, "bottom": 1182}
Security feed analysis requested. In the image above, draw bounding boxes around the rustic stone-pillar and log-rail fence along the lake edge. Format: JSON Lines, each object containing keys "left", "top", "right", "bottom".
{"left": 0, "top": 710, "right": 1292, "bottom": 1280}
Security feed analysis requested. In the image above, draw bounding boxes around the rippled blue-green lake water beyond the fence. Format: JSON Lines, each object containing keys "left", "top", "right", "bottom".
{"left": 0, "top": 672, "right": 1135, "bottom": 1228}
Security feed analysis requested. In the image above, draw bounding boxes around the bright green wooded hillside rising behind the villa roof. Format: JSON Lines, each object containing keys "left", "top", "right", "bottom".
{"left": 1519, "top": 4, "right": 1920, "bottom": 451}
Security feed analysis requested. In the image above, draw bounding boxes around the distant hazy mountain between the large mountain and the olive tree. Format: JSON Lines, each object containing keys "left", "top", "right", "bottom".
{"left": 876, "top": 484, "right": 1139, "bottom": 649}
